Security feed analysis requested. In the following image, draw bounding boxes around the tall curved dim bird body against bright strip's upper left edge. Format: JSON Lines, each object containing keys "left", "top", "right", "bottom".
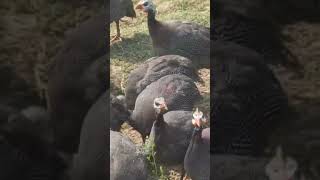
{"left": 48, "top": 12, "right": 108, "bottom": 154}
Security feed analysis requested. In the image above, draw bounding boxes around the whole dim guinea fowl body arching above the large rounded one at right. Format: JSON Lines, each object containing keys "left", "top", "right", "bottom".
{"left": 211, "top": 6, "right": 303, "bottom": 73}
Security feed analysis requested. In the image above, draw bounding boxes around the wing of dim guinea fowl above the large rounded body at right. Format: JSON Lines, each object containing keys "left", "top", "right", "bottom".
{"left": 213, "top": 15, "right": 286, "bottom": 64}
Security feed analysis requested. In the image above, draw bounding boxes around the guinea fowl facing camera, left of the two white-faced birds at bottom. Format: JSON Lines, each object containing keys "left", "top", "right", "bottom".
{"left": 150, "top": 97, "right": 193, "bottom": 179}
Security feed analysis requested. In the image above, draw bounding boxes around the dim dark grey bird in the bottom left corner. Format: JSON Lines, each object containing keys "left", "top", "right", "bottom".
{"left": 0, "top": 106, "right": 67, "bottom": 180}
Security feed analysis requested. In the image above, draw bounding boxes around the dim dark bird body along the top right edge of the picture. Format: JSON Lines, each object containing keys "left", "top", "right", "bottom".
{"left": 214, "top": 0, "right": 320, "bottom": 25}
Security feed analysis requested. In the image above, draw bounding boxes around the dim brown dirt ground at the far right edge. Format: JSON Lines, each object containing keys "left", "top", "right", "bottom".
{"left": 276, "top": 22, "right": 320, "bottom": 106}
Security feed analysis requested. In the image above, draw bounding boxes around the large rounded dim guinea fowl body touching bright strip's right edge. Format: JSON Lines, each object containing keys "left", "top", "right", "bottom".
{"left": 211, "top": 42, "right": 288, "bottom": 155}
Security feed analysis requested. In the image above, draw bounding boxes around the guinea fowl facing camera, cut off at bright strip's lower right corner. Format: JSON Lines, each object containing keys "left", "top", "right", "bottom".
{"left": 184, "top": 108, "right": 210, "bottom": 180}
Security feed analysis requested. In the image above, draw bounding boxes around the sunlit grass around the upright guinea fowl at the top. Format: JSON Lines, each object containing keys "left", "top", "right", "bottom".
{"left": 110, "top": 0, "right": 210, "bottom": 93}
